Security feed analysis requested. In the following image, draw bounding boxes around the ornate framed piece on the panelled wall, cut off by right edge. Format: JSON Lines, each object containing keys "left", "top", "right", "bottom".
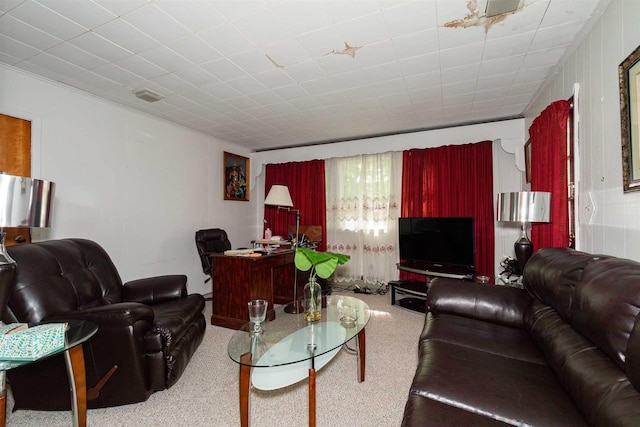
{"left": 618, "top": 46, "right": 640, "bottom": 192}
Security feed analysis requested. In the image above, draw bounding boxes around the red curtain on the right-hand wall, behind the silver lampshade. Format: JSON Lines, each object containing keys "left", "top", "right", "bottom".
{"left": 529, "top": 100, "right": 571, "bottom": 250}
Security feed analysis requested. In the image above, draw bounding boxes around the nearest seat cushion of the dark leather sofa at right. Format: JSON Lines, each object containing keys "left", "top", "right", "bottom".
{"left": 411, "top": 340, "right": 586, "bottom": 426}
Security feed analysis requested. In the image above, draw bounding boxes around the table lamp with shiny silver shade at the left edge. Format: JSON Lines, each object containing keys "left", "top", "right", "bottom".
{"left": 0, "top": 174, "right": 55, "bottom": 319}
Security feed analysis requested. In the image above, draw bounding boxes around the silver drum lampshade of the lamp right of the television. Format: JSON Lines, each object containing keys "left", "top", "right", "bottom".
{"left": 498, "top": 191, "right": 551, "bottom": 223}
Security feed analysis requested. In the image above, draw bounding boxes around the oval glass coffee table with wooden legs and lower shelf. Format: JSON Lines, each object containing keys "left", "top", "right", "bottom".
{"left": 227, "top": 295, "right": 370, "bottom": 427}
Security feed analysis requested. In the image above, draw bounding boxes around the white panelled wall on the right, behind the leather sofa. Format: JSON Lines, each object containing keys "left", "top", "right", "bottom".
{"left": 526, "top": 0, "right": 640, "bottom": 260}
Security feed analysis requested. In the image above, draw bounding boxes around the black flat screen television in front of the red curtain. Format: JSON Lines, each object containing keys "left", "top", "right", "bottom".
{"left": 398, "top": 217, "right": 475, "bottom": 272}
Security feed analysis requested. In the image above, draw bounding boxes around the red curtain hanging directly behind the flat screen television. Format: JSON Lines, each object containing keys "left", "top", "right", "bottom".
{"left": 401, "top": 141, "right": 495, "bottom": 277}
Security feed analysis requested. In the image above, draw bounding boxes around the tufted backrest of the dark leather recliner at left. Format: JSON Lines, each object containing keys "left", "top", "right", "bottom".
{"left": 4, "top": 239, "right": 122, "bottom": 322}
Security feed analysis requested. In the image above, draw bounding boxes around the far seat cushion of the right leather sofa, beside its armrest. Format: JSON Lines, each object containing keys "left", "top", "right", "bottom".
{"left": 420, "top": 313, "right": 547, "bottom": 365}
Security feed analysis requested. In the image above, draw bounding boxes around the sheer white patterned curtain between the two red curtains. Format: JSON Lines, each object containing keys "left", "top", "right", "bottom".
{"left": 325, "top": 152, "right": 402, "bottom": 283}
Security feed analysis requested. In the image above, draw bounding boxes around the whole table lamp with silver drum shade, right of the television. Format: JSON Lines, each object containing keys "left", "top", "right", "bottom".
{"left": 498, "top": 191, "right": 551, "bottom": 274}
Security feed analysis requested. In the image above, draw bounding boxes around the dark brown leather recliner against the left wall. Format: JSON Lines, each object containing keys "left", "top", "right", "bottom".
{"left": 3, "top": 239, "right": 206, "bottom": 410}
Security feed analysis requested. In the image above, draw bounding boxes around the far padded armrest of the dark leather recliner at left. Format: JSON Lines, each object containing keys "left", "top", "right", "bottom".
{"left": 122, "top": 274, "right": 187, "bottom": 305}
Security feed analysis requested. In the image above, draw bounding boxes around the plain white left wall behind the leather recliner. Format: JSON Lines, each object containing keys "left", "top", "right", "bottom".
{"left": 0, "top": 66, "right": 255, "bottom": 293}
